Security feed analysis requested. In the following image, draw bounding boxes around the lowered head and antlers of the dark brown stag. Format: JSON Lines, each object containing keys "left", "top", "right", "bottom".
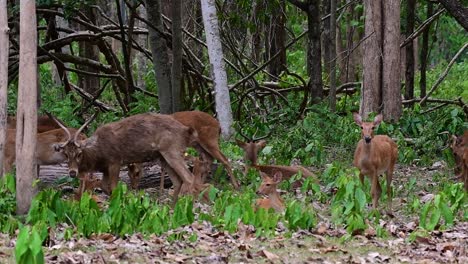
{"left": 51, "top": 113, "right": 97, "bottom": 177}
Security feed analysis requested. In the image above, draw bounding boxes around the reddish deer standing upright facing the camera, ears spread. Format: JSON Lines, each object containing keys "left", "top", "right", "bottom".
{"left": 353, "top": 113, "right": 398, "bottom": 211}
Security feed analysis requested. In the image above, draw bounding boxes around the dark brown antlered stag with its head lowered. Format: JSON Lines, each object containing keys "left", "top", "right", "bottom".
{"left": 54, "top": 113, "right": 202, "bottom": 205}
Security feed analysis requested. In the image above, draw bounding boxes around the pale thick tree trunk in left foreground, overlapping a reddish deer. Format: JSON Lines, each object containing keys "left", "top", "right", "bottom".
{"left": 16, "top": 0, "right": 38, "bottom": 215}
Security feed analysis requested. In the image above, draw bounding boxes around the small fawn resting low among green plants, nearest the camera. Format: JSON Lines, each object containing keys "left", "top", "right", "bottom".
{"left": 256, "top": 172, "right": 285, "bottom": 213}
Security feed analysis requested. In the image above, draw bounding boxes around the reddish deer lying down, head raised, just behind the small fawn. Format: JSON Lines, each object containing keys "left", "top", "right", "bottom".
{"left": 236, "top": 139, "right": 315, "bottom": 188}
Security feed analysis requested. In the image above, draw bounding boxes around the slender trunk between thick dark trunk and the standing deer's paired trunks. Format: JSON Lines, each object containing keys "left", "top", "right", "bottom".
{"left": 329, "top": 0, "right": 336, "bottom": 112}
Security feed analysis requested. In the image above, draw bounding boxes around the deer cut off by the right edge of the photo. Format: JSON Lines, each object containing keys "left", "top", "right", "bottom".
{"left": 450, "top": 130, "right": 468, "bottom": 192}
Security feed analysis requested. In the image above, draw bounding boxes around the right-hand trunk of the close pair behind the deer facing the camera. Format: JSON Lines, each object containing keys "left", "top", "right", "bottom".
{"left": 382, "top": 0, "right": 400, "bottom": 122}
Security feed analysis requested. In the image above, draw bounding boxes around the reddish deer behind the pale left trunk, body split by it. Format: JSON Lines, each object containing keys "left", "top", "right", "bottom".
{"left": 3, "top": 128, "right": 86, "bottom": 174}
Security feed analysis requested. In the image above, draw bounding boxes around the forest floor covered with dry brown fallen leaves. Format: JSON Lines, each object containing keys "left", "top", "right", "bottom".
{"left": 0, "top": 164, "right": 468, "bottom": 263}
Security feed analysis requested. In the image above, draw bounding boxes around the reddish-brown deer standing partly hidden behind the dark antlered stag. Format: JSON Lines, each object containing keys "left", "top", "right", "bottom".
{"left": 129, "top": 111, "right": 239, "bottom": 191}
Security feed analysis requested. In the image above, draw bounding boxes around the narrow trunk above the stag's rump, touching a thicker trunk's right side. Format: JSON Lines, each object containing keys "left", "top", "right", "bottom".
{"left": 171, "top": 0, "right": 184, "bottom": 112}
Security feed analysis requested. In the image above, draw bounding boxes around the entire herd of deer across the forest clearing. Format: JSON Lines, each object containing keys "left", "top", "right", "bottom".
{"left": 3, "top": 111, "right": 468, "bottom": 211}
